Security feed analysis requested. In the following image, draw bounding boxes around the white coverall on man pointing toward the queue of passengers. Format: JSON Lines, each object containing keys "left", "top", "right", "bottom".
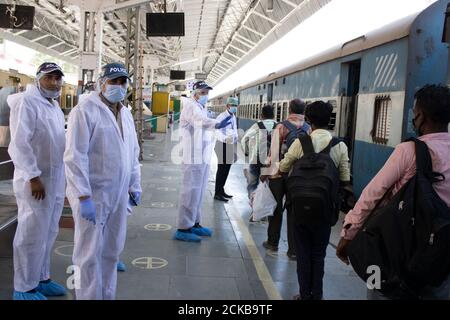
{"left": 178, "top": 98, "right": 218, "bottom": 229}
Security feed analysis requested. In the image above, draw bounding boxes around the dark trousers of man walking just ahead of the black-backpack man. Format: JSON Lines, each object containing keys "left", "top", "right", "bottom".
{"left": 267, "top": 177, "right": 295, "bottom": 253}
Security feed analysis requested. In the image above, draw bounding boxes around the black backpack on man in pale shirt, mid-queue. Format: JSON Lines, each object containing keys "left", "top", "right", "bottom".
{"left": 287, "top": 135, "right": 340, "bottom": 226}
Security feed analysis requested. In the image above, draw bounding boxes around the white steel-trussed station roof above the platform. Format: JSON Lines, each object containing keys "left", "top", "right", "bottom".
{"left": 0, "top": 0, "right": 331, "bottom": 85}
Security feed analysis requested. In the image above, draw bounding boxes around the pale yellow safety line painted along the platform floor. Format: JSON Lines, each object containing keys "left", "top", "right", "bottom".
{"left": 224, "top": 203, "right": 283, "bottom": 300}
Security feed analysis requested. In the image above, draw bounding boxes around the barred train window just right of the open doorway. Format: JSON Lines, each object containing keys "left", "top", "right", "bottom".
{"left": 370, "top": 96, "right": 392, "bottom": 144}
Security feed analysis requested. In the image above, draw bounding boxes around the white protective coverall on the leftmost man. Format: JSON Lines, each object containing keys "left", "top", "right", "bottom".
{"left": 7, "top": 84, "right": 65, "bottom": 292}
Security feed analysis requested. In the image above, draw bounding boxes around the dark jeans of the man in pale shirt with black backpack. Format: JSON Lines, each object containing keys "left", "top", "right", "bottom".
{"left": 294, "top": 225, "right": 331, "bottom": 300}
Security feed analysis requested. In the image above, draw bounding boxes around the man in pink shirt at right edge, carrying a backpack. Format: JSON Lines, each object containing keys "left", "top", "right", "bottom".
{"left": 336, "top": 85, "right": 450, "bottom": 299}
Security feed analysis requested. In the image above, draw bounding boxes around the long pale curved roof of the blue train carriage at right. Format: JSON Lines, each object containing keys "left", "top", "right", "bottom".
{"left": 214, "top": 12, "right": 421, "bottom": 97}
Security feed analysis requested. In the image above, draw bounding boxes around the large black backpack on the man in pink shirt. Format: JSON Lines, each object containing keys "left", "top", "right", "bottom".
{"left": 347, "top": 138, "right": 450, "bottom": 299}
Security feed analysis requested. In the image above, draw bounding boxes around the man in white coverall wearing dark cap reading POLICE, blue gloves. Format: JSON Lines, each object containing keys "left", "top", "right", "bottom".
{"left": 64, "top": 63, "right": 141, "bottom": 300}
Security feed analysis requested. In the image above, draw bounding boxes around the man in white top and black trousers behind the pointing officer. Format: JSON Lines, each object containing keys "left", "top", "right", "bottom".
{"left": 214, "top": 97, "right": 239, "bottom": 202}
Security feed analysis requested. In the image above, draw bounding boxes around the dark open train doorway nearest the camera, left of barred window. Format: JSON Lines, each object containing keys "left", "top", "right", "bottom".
{"left": 339, "top": 60, "right": 361, "bottom": 167}
